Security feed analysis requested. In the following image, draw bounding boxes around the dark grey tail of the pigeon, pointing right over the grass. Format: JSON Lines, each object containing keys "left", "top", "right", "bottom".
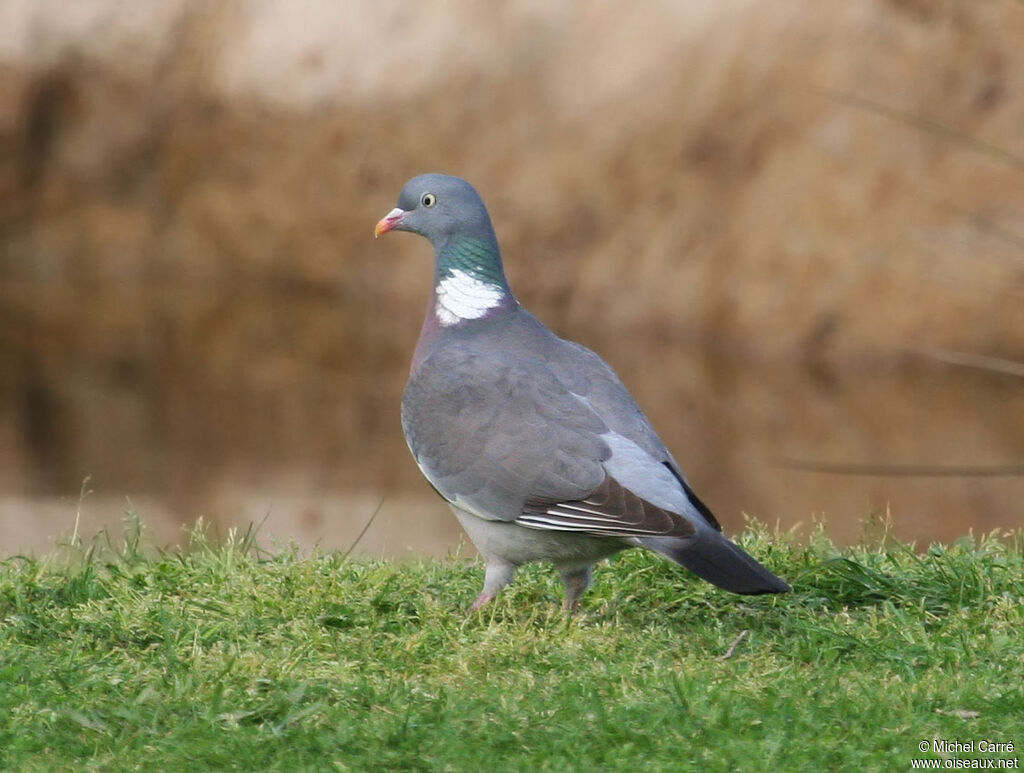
{"left": 637, "top": 529, "right": 793, "bottom": 596}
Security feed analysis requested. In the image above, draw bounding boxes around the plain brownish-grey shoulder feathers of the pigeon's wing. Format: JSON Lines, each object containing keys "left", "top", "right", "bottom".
{"left": 402, "top": 345, "right": 610, "bottom": 521}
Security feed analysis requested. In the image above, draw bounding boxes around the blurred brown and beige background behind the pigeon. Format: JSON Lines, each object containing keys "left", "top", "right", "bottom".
{"left": 0, "top": 0, "right": 1024, "bottom": 556}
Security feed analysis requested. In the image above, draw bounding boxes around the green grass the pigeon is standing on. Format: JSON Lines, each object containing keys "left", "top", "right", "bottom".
{"left": 0, "top": 526, "right": 1024, "bottom": 771}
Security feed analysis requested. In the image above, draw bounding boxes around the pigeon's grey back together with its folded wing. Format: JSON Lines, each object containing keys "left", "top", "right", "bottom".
{"left": 402, "top": 312, "right": 717, "bottom": 538}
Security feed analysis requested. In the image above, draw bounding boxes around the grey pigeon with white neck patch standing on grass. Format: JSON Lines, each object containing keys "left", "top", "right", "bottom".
{"left": 374, "top": 174, "right": 791, "bottom": 611}
